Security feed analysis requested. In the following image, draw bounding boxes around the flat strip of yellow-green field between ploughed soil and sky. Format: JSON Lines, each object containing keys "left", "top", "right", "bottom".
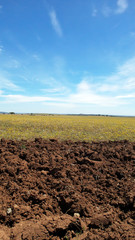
{"left": 0, "top": 115, "right": 135, "bottom": 141}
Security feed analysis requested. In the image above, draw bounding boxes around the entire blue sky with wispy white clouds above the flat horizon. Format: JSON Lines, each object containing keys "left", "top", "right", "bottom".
{"left": 0, "top": 0, "right": 135, "bottom": 115}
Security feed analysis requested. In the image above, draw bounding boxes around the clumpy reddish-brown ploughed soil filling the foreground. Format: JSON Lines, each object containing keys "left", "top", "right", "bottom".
{"left": 0, "top": 139, "right": 135, "bottom": 240}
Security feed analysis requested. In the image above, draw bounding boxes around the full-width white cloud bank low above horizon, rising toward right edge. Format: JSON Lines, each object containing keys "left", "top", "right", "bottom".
{"left": 0, "top": 58, "right": 135, "bottom": 111}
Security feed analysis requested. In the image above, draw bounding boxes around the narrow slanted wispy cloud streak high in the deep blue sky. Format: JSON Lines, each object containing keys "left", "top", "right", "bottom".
{"left": 49, "top": 10, "right": 62, "bottom": 37}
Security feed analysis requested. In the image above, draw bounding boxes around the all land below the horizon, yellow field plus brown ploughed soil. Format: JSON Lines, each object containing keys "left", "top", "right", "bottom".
{"left": 0, "top": 115, "right": 135, "bottom": 240}
